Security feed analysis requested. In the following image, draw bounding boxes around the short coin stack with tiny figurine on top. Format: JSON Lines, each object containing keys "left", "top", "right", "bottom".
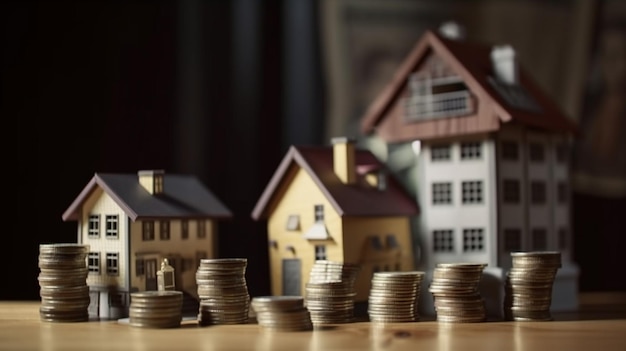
{"left": 128, "top": 290, "right": 183, "bottom": 328}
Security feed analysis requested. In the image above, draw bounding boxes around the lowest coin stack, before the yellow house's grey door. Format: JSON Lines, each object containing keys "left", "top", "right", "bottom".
{"left": 250, "top": 296, "right": 313, "bottom": 331}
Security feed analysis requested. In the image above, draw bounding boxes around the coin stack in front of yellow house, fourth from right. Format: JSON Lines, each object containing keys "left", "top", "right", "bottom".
{"left": 305, "top": 260, "right": 360, "bottom": 325}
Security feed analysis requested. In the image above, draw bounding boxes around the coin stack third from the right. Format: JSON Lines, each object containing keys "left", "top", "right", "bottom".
{"left": 367, "top": 271, "right": 424, "bottom": 323}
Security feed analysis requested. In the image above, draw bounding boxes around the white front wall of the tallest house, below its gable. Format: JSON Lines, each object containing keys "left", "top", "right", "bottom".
{"left": 418, "top": 135, "right": 497, "bottom": 271}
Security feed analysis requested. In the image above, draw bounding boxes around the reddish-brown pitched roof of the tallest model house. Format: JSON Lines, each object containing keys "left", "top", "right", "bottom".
{"left": 361, "top": 31, "right": 576, "bottom": 138}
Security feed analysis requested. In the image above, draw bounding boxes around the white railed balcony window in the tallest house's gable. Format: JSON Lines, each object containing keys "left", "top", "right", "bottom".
{"left": 405, "top": 72, "right": 474, "bottom": 122}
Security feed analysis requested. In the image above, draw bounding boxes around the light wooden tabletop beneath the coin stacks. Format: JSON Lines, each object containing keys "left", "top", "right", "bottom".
{"left": 0, "top": 293, "right": 626, "bottom": 351}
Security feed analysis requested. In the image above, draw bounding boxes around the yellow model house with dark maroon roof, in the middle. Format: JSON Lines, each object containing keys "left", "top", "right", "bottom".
{"left": 252, "top": 138, "right": 418, "bottom": 302}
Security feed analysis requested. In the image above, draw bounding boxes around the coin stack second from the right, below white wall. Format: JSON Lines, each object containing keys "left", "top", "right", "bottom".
{"left": 429, "top": 263, "right": 487, "bottom": 323}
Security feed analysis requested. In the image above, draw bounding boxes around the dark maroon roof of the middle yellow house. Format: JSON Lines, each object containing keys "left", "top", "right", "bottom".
{"left": 252, "top": 146, "right": 419, "bottom": 220}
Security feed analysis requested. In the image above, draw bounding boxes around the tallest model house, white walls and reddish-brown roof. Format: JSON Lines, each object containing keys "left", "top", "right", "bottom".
{"left": 361, "top": 31, "right": 578, "bottom": 309}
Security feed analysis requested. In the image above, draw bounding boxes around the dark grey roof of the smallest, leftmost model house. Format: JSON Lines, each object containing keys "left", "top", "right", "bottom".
{"left": 63, "top": 173, "right": 232, "bottom": 221}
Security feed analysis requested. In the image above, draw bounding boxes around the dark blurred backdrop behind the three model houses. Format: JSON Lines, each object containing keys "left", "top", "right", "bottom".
{"left": 0, "top": 0, "right": 626, "bottom": 299}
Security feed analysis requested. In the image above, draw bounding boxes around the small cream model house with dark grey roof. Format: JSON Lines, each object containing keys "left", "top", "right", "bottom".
{"left": 63, "top": 170, "right": 232, "bottom": 319}
